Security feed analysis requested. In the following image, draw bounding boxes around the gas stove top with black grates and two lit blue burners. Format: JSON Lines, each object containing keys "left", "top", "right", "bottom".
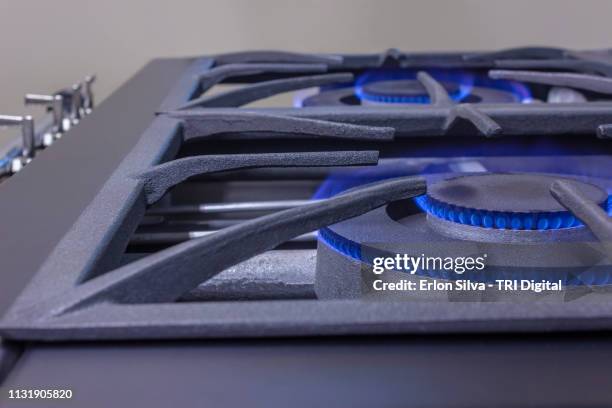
{"left": 0, "top": 47, "right": 612, "bottom": 406}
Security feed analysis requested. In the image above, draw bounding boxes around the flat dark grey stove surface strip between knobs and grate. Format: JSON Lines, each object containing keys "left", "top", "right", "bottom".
{"left": 0, "top": 58, "right": 193, "bottom": 380}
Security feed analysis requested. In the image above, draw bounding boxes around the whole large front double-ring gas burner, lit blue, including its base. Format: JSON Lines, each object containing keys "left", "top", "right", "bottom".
{"left": 315, "top": 173, "right": 612, "bottom": 300}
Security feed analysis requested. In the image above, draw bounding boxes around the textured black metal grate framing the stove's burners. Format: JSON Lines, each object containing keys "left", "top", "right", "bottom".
{"left": 0, "top": 48, "right": 612, "bottom": 340}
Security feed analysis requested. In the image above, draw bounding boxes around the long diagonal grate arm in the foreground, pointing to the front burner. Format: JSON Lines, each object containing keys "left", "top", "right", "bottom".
{"left": 22, "top": 177, "right": 426, "bottom": 316}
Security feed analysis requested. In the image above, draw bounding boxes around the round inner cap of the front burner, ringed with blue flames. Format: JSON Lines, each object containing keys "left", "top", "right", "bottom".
{"left": 419, "top": 174, "right": 608, "bottom": 230}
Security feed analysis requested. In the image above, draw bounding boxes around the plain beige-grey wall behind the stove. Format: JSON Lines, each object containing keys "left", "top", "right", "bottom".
{"left": 0, "top": 0, "right": 612, "bottom": 114}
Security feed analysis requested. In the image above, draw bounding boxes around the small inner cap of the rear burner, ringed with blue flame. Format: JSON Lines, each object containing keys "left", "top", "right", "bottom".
{"left": 359, "top": 79, "right": 460, "bottom": 103}
